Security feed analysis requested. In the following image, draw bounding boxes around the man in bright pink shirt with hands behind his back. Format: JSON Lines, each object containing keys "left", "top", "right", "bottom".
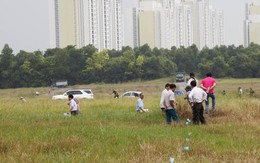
{"left": 201, "top": 72, "right": 216, "bottom": 114}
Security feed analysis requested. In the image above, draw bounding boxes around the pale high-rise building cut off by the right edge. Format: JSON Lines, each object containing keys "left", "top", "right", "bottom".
{"left": 244, "top": 3, "right": 260, "bottom": 47}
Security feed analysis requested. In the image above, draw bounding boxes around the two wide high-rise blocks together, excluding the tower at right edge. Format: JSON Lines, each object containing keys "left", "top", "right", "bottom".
{"left": 50, "top": 0, "right": 224, "bottom": 50}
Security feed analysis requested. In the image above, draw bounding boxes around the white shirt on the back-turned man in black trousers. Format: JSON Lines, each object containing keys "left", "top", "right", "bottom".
{"left": 189, "top": 87, "right": 207, "bottom": 103}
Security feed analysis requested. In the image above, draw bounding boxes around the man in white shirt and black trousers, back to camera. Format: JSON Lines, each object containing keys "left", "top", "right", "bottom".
{"left": 189, "top": 81, "right": 207, "bottom": 125}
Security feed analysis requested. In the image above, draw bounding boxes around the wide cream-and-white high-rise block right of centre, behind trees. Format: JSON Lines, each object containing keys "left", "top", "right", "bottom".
{"left": 124, "top": 0, "right": 224, "bottom": 49}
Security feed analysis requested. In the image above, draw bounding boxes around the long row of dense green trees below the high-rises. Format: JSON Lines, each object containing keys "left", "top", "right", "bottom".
{"left": 0, "top": 43, "right": 260, "bottom": 88}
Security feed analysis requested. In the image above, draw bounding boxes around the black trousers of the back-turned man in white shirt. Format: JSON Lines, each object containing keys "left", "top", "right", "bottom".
{"left": 192, "top": 103, "right": 206, "bottom": 125}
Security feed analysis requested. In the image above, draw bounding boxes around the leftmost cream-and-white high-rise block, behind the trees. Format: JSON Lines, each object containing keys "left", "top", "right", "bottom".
{"left": 50, "top": 0, "right": 123, "bottom": 50}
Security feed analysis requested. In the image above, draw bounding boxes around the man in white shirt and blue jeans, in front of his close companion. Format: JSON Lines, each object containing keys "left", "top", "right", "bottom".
{"left": 164, "top": 84, "right": 180, "bottom": 124}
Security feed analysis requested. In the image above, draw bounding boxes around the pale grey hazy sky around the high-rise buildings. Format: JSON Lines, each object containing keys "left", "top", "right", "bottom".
{"left": 0, "top": 0, "right": 260, "bottom": 53}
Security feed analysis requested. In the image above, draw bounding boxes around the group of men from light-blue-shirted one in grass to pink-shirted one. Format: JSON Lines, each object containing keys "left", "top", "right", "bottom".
{"left": 133, "top": 73, "right": 216, "bottom": 124}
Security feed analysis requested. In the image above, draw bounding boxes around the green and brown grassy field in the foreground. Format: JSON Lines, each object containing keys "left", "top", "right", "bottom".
{"left": 0, "top": 79, "right": 260, "bottom": 163}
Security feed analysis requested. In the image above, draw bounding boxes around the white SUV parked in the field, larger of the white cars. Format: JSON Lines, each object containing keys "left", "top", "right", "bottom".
{"left": 52, "top": 89, "right": 94, "bottom": 100}
